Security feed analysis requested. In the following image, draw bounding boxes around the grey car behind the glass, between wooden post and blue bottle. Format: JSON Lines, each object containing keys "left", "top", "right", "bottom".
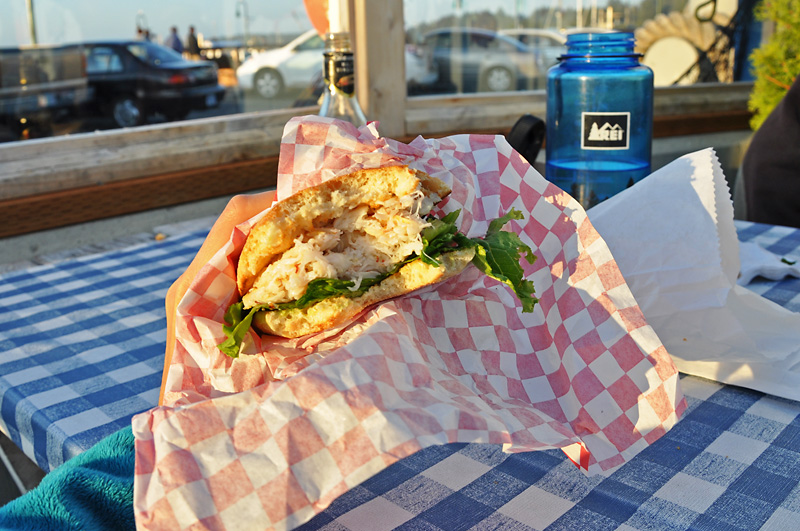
{"left": 422, "top": 28, "right": 546, "bottom": 92}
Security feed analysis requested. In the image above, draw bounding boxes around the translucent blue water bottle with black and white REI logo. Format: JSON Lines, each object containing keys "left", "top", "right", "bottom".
{"left": 545, "top": 32, "right": 653, "bottom": 209}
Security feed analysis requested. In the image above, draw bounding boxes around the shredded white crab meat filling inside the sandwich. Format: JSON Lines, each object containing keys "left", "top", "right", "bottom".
{"left": 244, "top": 191, "right": 439, "bottom": 307}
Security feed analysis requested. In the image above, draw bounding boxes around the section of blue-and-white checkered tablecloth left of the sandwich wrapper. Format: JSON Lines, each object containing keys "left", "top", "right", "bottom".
{"left": 0, "top": 230, "right": 207, "bottom": 471}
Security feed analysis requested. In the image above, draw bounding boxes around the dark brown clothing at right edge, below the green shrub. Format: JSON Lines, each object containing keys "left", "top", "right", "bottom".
{"left": 742, "top": 76, "right": 800, "bottom": 227}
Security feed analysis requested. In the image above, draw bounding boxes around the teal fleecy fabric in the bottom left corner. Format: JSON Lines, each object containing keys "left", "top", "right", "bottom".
{"left": 0, "top": 426, "right": 136, "bottom": 531}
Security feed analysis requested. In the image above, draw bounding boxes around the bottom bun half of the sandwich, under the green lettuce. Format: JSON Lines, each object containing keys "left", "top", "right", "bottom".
{"left": 253, "top": 248, "right": 475, "bottom": 338}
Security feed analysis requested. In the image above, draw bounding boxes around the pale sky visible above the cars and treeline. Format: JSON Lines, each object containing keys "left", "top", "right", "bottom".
{"left": 0, "top": 0, "right": 560, "bottom": 47}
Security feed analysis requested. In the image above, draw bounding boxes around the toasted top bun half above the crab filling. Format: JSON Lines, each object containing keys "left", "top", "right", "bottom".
{"left": 236, "top": 166, "right": 450, "bottom": 295}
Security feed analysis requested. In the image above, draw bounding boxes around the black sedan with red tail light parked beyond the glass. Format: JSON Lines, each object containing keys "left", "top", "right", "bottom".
{"left": 82, "top": 41, "right": 225, "bottom": 127}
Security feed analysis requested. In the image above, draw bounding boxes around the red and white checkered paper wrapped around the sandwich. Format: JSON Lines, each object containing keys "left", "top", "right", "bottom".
{"left": 133, "top": 116, "right": 686, "bottom": 530}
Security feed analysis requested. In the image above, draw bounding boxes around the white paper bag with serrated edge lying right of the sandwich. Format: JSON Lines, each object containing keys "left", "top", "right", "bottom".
{"left": 588, "top": 149, "right": 800, "bottom": 400}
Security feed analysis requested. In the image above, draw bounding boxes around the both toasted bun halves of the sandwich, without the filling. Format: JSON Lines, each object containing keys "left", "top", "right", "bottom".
{"left": 237, "top": 166, "right": 474, "bottom": 337}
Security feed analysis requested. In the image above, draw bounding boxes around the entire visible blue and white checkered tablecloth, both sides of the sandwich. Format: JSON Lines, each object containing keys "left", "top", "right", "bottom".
{"left": 0, "top": 222, "right": 800, "bottom": 531}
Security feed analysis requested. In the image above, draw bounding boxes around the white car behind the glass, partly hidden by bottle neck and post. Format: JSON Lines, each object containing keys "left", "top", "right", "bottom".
{"left": 236, "top": 29, "right": 437, "bottom": 99}
